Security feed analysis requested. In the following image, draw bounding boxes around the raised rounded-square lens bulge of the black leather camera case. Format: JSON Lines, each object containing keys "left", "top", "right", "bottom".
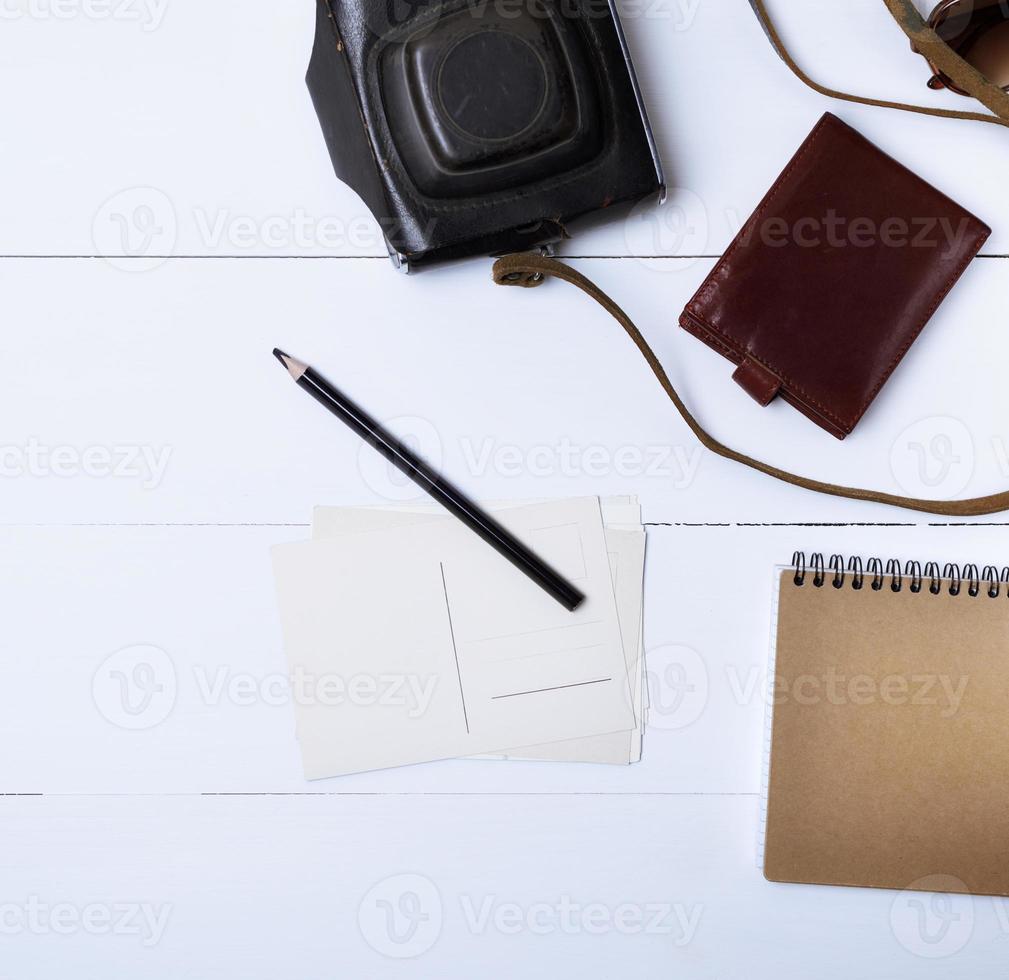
{"left": 378, "top": 0, "right": 602, "bottom": 198}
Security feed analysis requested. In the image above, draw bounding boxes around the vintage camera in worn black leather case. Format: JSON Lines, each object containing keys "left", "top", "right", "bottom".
{"left": 308, "top": 0, "right": 664, "bottom": 271}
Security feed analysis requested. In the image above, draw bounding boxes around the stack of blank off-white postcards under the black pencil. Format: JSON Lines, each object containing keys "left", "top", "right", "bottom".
{"left": 273, "top": 497, "right": 647, "bottom": 779}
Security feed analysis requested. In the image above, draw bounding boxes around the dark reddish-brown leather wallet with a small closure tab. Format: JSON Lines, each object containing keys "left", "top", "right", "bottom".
{"left": 680, "top": 113, "right": 991, "bottom": 439}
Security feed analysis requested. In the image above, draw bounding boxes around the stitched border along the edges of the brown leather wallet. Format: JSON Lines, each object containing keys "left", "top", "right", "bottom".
{"left": 687, "top": 116, "right": 991, "bottom": 431}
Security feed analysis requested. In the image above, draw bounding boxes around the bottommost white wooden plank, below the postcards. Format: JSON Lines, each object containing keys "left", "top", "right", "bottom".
{"left": 0, "top": 796, "right": 1007, "bottom": 980}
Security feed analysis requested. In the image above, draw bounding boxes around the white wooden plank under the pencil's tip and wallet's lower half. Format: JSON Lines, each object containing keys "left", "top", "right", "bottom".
{"left": 0, "top": 259, "right": 1009, "bottom": 524}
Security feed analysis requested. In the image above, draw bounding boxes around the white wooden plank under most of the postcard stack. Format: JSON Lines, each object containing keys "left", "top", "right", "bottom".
{"left": 0, "top": 526, "right": 1009, "bottom": 793}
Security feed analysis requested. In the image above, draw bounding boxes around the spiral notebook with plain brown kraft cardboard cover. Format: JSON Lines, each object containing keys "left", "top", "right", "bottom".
{"left": 763, "top": 555, "right": 1009, "bottom": 895}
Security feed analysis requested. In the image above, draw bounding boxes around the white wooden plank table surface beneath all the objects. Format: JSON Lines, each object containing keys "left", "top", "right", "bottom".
{"left": 0, "top": 0, "right": 1009, "bottom": 980}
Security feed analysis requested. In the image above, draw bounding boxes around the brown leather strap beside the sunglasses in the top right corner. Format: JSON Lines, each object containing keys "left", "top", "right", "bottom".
{"left": 750, "top": 0, "right": 1009, "bottom": 126}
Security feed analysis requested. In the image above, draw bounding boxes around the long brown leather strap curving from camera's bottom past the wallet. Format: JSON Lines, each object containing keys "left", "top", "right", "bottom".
{"left": 493, "top": 252, "right": 1009, "bottom": 517}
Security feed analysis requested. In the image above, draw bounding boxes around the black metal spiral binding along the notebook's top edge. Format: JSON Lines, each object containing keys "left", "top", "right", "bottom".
{"left": 792, "top": 551, "right": 1009, "bottom": 598}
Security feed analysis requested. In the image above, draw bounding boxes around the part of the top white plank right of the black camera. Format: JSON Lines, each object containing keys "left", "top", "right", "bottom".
{"left": 601, "top": 0, "right": 1009, "bottom": 255}
